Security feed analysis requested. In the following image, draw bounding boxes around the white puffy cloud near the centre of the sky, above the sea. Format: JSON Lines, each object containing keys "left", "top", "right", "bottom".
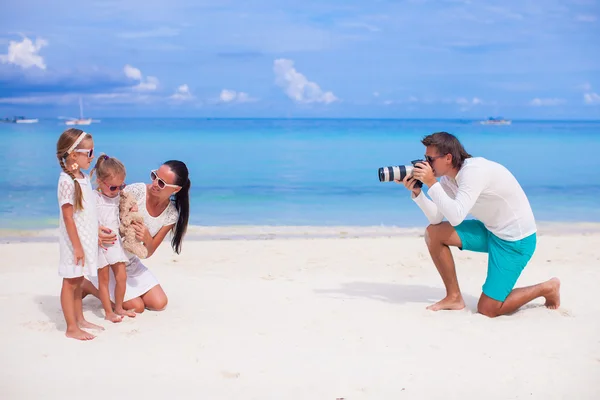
{"left": 273, "top": 58, "right": 339, "bottom": 104}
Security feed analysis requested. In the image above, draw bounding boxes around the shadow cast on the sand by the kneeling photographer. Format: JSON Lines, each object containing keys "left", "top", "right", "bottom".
{"left": 315, "top": 282, "right": 479, "bottom": 310}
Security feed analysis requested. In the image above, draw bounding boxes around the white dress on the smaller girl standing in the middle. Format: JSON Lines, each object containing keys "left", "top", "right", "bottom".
{"left": 95, "top": 191, "right": 129, "bottom": 269}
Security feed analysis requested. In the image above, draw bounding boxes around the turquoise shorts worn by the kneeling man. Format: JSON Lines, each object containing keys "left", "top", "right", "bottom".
{"left": 454, "top": 220, "right": 537, "bottom": 302}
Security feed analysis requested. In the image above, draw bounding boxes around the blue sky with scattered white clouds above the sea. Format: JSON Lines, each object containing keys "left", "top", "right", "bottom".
{"left": 0, "top": 0, "right": 600, "bottom": 119}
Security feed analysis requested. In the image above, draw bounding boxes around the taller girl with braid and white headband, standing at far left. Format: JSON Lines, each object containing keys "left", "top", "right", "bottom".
{"left": 56, "top": 128, "right": 104, "bottom": 340}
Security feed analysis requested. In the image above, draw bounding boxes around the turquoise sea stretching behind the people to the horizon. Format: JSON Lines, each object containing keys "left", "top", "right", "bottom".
{"left": 0, "top": 119, "right": 600, "bottom": 229}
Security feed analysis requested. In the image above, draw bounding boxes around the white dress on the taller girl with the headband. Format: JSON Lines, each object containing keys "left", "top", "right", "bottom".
{"left": 57, "top": 171, "right": 98, "bottom": 278}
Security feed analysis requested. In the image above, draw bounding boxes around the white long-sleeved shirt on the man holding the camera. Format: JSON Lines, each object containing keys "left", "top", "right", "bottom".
{"left": 412, "top": 157, "right": 537, "bottom": 241}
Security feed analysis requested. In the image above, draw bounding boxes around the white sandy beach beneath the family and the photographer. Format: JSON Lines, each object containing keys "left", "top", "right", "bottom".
{"left": 0, "top": 224, "right": 600, "bottom": 400}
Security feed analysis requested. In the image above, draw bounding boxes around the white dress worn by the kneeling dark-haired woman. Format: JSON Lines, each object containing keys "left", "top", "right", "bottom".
{"left": 88, "top": 183, "right": 179, "bottom": 302}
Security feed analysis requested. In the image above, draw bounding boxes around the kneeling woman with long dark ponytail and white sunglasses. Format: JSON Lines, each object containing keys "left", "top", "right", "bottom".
{"left": 83, "top": 160, "right": 191, "bottom": 313}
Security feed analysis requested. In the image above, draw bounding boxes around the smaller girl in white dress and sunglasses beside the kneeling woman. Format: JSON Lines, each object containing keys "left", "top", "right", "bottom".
{"left": 90, "top": 154, "right": 135, "bottom": 322}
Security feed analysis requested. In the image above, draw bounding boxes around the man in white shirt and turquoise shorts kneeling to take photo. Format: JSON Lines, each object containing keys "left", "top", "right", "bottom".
{"left": 396, "top": 132, "right": 560, "bottom": 317}
